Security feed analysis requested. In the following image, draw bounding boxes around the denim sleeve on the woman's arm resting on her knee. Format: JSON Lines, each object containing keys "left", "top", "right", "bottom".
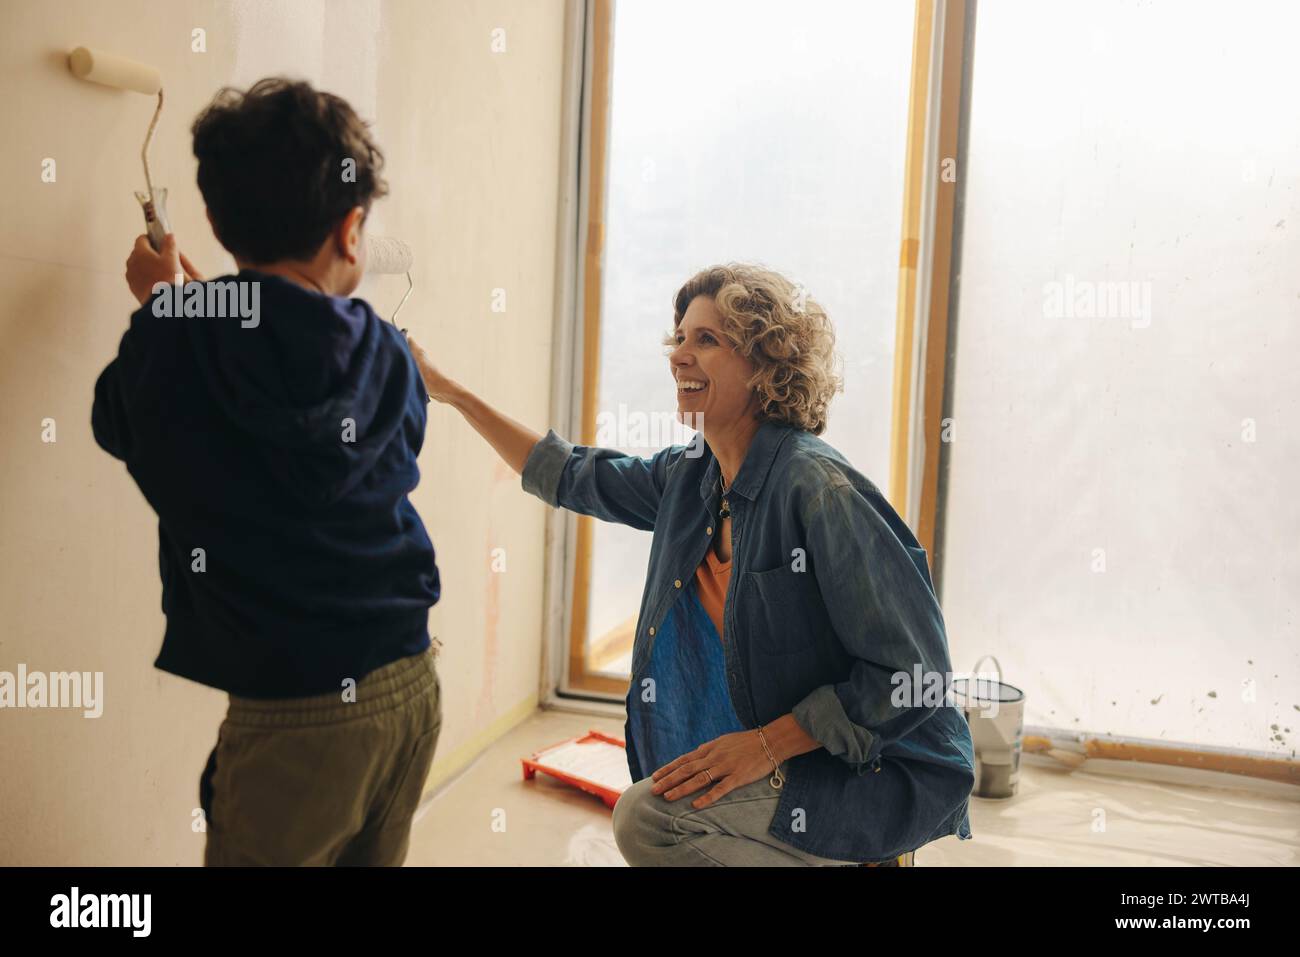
{"left": 792, "top": 484, "right": 950, "bottom": 774}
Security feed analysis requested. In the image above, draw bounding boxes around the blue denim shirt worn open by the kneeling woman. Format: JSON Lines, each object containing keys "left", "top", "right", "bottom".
{"left": 523, "top": 420, "right": 975, "bottom": 862}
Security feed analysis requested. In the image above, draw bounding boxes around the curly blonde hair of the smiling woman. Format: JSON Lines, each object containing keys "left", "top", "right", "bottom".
{"left": 663, "top": 263, "right": 844, "bottom": 436}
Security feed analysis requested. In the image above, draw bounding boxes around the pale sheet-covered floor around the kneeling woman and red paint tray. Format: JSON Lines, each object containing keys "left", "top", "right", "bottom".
{"left": 407, "top": 711, "right": 1300, "bottom": 867}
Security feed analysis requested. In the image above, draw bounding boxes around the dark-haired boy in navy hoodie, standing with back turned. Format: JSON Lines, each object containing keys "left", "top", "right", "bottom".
{"left": 91, "top": 78, "right": 442, "bottom": 866}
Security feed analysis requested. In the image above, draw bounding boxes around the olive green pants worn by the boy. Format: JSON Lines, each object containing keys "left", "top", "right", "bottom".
{"left": 199, "top": 649, "right": 442, "bottom": 867}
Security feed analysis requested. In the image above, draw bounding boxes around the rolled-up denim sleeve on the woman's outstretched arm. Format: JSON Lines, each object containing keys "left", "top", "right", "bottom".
{"left": 521, "top": 429, "right": 686, "bottom": 531}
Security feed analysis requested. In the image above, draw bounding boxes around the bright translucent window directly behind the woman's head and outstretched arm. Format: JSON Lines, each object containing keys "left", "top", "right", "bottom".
{"left": 569, "top": 0, "right": 915, "bottom": 690}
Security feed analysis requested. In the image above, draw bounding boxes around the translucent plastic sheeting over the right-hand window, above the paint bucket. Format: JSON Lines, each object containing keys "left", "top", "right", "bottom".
{"left": 943, "top": 0, "right": 1300, "bottom": 757}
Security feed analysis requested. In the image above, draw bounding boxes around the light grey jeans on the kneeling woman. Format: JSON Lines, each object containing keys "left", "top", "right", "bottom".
{"left": 614, "top": 763, "right": 858, "bottom": 867}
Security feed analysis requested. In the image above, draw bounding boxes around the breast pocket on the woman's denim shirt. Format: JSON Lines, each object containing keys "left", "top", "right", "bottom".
{"left": 736, "top": 564, "right": 826, "bottom": 655}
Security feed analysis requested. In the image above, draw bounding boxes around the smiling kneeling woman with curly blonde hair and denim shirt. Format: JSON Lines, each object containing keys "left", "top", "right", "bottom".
{"left": 411, "top": 264, "right": 974, "bottom": 866}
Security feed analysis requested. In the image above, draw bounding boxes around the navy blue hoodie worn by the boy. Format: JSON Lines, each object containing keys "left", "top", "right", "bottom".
{"left": 91, "top": 269, "right": 439, "bottom": 698}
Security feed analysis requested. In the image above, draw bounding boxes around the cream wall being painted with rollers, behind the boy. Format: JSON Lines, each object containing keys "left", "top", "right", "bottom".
{"left": 0, "top": 0, "right": 564, "bottom": 865}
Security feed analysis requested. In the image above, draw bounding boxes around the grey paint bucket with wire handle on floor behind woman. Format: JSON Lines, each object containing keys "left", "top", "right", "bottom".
{"left": 953, "top": 654, "right": 1024, "bottom": 797}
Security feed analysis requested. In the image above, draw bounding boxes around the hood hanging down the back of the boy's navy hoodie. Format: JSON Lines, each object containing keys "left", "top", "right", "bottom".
{"left": 182, "top": 269, "right": 424, "bottom": 505}
